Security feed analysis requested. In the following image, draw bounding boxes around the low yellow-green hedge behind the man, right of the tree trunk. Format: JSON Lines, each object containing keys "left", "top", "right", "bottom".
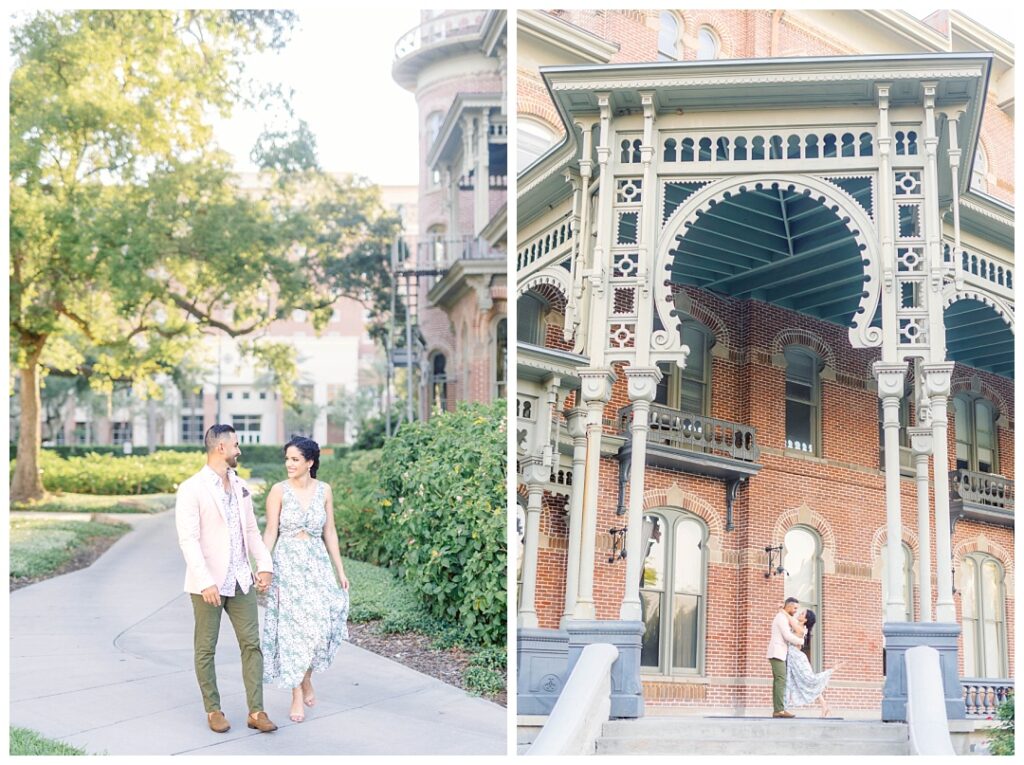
{"left": 10, "top": 451, "right": 249, "bottom": 495}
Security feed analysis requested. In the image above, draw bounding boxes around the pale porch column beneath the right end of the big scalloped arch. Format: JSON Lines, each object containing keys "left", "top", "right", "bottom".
{"left": 872, "top": 362, "right": 906, "bottom": 622}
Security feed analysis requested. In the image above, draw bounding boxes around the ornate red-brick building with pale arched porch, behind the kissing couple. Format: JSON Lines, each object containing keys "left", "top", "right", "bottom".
{"left": 517, "top": 10, "right": 1015, "bottom": 719}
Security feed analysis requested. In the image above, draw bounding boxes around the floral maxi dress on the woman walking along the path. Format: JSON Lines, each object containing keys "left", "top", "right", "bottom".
{"left": 262, "top": 481, "right": 348, "bottom": 688}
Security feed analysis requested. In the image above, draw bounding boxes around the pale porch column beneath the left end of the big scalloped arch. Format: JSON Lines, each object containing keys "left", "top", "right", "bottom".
{"left": 618, "top": 365, "right": 662, "bottom": 622}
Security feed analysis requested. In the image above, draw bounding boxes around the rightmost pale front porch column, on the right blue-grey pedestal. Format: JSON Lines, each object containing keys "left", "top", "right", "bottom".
{"left": 922, "top": 362, "right": 956, "bottom": 624}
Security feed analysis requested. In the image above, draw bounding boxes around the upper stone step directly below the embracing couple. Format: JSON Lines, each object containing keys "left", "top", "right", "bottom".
{"left": 601, "top": 717, "right": 907, "bottom": 741}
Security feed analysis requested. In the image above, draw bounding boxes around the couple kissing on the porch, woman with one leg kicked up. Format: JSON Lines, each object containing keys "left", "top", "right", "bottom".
{"left": 768, "top": 598, "right": 841, "bottom": 717}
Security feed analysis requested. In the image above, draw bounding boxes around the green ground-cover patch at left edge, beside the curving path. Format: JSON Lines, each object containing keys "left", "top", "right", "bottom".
{"left": 10, "top": 518, "right": 131, "bottom": 589}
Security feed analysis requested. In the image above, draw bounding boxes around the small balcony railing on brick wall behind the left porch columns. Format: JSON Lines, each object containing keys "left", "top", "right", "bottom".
{"left": 618, "top": 403, "right": 759, "bottom": 462}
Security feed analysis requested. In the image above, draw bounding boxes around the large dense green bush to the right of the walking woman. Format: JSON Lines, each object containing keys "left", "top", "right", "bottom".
{"left": 379, "top": 400, "right": 507, "bottom": 645}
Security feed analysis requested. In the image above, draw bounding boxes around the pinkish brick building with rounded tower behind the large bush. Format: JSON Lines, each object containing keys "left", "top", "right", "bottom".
{"left": 392, "top": 10, "right": 508, "bottom": 418}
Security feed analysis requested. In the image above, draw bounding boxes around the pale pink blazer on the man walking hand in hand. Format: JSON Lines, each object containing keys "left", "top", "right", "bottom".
{"left": 174, "top": 468, "right": 273, "bottom": 595}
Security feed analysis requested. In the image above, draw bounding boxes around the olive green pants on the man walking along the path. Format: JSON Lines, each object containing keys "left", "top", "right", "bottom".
{"left": 191, "top": 584, "right": 263, "bottom": 713}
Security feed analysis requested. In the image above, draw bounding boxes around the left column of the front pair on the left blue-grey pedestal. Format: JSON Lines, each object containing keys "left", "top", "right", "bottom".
{"left": 572, "top": 369, "right": 615, "bottom": 620}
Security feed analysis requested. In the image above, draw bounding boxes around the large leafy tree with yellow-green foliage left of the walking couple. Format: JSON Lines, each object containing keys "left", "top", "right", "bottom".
{"left": 10, "top": 10, "right": 398, "bottom": 501}
